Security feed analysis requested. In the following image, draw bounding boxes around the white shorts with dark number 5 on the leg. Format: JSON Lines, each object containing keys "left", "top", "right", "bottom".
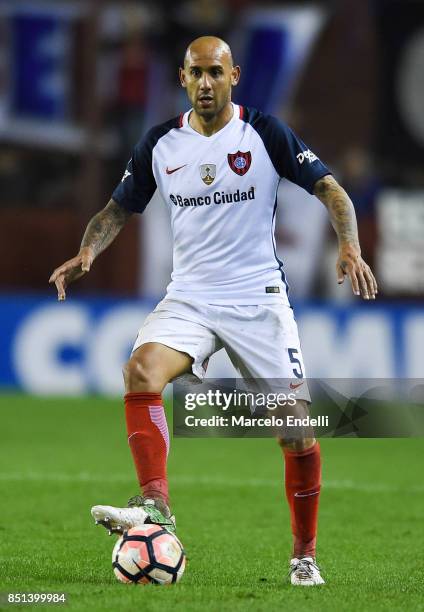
{"left": 133, "top": 298, "right": 310, "bottom": 401}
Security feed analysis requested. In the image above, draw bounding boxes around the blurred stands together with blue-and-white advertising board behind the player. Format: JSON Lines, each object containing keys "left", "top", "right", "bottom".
{"left": 0, "top": 0, "right": 424, "bottom": 395}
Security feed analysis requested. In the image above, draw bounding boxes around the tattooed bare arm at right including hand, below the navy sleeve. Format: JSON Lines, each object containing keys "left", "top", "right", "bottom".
{"left": 314, "top": 174, "right": 377, "bottom": 300}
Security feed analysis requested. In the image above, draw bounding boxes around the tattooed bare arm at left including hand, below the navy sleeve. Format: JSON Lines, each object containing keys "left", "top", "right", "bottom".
{"left": 49, "top": 200, "right": 132, "bottom": 301}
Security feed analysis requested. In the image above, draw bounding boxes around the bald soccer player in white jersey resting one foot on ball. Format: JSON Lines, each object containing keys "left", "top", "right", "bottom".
{"left": 50, "top": 36, "right": 377, "bottom": 586}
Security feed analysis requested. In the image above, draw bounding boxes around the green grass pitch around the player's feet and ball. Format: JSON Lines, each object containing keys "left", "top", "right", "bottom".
{"left": 0, "top": 395, "right": 424, "bottom": 612}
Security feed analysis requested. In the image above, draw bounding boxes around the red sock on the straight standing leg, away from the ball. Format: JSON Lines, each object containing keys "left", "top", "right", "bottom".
{"left": 284, "top": 442, "right": 321, "bottom": 558}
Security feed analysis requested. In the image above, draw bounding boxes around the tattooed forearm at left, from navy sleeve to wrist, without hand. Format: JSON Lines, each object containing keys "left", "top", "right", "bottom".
{"left": 81, "top": 200, "right": 132, "bottom": 257}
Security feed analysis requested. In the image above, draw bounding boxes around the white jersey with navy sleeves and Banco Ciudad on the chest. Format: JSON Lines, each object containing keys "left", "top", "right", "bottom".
{"left": 112, "top": 104, "right": 329, "bottom": 304}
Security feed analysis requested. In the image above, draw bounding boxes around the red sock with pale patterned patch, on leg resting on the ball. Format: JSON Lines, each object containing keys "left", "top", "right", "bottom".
{"left": 124, "top": 393, "right": 169, "bottom": 504}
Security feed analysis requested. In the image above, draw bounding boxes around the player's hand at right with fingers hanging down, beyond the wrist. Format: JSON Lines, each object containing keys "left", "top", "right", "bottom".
{"left": 336, "top": 244, "right": 378, "bottom": 300}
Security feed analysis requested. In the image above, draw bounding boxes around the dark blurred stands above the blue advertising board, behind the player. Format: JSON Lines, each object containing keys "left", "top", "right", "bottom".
{"left": 0, "top": 0, "right": 424, "bottom": 300}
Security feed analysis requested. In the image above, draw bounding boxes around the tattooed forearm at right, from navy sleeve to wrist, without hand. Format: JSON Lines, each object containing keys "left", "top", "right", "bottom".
{"left": 314, "top": 175, "right": 359, "bottom": 247}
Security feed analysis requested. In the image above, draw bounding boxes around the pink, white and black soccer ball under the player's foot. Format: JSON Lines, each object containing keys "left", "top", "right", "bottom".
{"left": 112, "top": 524, "right": 186, "bottom": 584}
